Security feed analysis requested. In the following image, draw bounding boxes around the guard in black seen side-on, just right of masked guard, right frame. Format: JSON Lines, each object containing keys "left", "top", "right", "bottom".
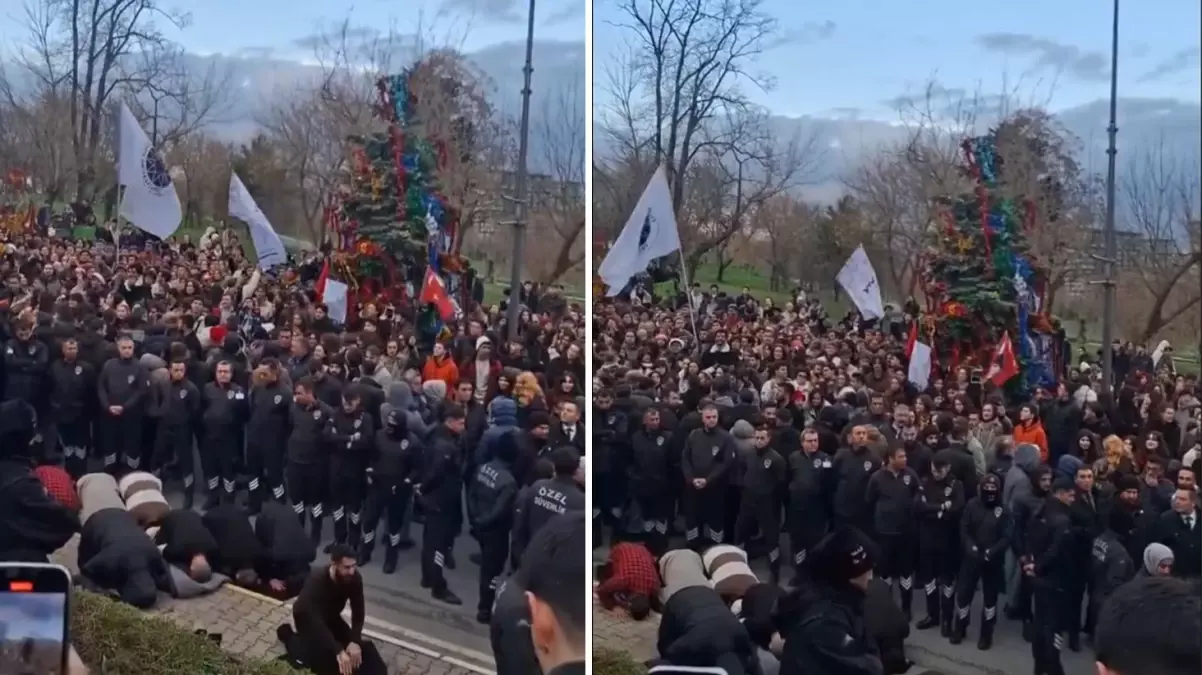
{"left": 1022, "top": 477, "right": 1072, "bottom": 675}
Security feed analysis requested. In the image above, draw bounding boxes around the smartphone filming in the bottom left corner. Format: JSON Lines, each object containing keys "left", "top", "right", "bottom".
{"left": 0, "top": 563, "right": 71, "bottom": 675}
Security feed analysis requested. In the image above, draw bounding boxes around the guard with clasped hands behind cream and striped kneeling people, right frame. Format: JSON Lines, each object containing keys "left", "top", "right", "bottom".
{"left": 680, "top": 404, "right": 737, "bottom": 549}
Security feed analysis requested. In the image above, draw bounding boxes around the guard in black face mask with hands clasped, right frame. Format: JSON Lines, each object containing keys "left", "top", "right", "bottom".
{"left": 903, "top": 454, "right": 964, "bottom": 638}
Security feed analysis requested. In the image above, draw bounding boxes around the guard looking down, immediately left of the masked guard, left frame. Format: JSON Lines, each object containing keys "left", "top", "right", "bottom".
{"left": 326, "top": 384, "right": 375, "bottom": 552}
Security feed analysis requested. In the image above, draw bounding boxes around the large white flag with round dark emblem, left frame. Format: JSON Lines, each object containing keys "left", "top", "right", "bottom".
{"left": 117, "top": 103, "right": 184, "bottom": 239}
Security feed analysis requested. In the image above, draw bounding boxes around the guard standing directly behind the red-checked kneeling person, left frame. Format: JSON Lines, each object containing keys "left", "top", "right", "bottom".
{"left": 49, "top": 338, "right": 96, "bottom": 479}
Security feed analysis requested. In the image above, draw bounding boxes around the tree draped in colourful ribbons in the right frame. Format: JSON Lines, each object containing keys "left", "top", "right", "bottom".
{"left": 918, "top": 131, "right": 1059, "bottom": 396}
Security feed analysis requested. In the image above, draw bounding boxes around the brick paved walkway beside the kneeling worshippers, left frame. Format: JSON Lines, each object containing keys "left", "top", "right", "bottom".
{"left": 52, "top": 536, "right": 476, "bottom": 675}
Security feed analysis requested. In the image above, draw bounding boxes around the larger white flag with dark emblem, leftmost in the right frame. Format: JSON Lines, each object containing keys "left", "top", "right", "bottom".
{"left": 597, "top": 166, "right": 680, "bottom": 295}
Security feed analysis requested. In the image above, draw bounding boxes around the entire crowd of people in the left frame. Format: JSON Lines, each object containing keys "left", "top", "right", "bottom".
{"left": 0, "top": 216, "right": 585, "bottom": 673}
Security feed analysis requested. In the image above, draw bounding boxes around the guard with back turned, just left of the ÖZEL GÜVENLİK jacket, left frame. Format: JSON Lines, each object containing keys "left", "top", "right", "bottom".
{"left": 468, "top": 431, "right": 518, "bottom": 623}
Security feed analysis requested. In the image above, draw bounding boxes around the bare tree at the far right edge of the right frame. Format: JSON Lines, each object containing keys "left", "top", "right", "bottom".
{"left": 1121, "top": 139, "right": 1202, "bottom": 342}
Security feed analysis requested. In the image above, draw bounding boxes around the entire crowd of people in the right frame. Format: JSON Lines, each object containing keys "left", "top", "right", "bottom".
{"left": 590, "top": 286, "right": 1202, "bottom": 675}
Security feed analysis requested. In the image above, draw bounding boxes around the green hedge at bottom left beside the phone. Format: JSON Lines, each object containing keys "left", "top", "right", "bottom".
{"left": 71, "top": 591, "right": 301, "bottom": 675}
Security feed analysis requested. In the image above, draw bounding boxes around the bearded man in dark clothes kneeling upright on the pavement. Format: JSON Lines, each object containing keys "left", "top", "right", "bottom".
{"left": 276, "top": 545, "right": 387, "bottom": 675}
